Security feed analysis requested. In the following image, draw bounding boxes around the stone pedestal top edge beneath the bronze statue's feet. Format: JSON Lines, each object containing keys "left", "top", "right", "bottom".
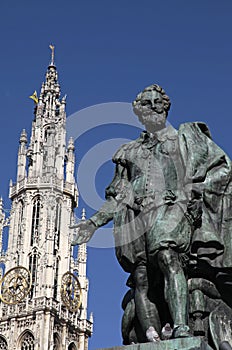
{"left": 98, "top": 337, "right": 212, "bottom": 350}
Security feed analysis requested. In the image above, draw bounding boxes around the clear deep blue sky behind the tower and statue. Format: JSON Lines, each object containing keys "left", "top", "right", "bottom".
{"left": 0, "top": 0, "right": 232, "bottom": 349}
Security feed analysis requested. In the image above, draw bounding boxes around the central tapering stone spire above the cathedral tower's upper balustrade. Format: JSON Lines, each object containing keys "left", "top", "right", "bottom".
{"left": 21, "top": 45, "right": 69, "bottom": 184}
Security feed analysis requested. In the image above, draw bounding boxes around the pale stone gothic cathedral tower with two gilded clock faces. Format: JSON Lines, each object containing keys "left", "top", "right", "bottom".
{"left": 0, "top": 46, "right": 92, "bottom": 350}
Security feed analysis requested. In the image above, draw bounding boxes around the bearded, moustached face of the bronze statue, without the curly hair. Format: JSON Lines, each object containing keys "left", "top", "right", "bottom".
{"left": 134, "top": 90, "right": 166, "bottom": 132}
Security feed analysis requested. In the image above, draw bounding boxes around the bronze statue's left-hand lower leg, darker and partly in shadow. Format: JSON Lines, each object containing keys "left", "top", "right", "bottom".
{"left": 133, "top": 265, "right": 161, "bottom": 335}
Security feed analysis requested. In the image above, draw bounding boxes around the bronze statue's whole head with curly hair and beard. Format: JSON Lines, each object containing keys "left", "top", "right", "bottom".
{"left": 133, "top": 84, "right": 171, "bottom": 132}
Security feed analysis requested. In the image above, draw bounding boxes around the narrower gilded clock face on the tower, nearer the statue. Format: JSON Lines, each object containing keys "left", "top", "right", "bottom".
{"left": 61, "top": 272, "right": 82, "bottom": 312}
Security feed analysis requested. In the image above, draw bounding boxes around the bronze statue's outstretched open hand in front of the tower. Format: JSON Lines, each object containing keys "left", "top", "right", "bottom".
{"left": 70, "top": 220, "right": 97, "bottom": 246}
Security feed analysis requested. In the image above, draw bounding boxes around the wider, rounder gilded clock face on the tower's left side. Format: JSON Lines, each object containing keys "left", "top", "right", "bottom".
{"left": 0, "top": 266, "right": 32, "bottom": 304}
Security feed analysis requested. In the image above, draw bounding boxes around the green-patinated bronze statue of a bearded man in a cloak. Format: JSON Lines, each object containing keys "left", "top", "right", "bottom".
{"left": 72, "top": 84, "right": 232, "bottom": 350}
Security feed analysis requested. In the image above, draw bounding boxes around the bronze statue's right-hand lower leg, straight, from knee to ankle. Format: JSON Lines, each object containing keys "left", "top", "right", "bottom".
{"left": 157, "top": 249, "right": 188, "bottom": 327}
